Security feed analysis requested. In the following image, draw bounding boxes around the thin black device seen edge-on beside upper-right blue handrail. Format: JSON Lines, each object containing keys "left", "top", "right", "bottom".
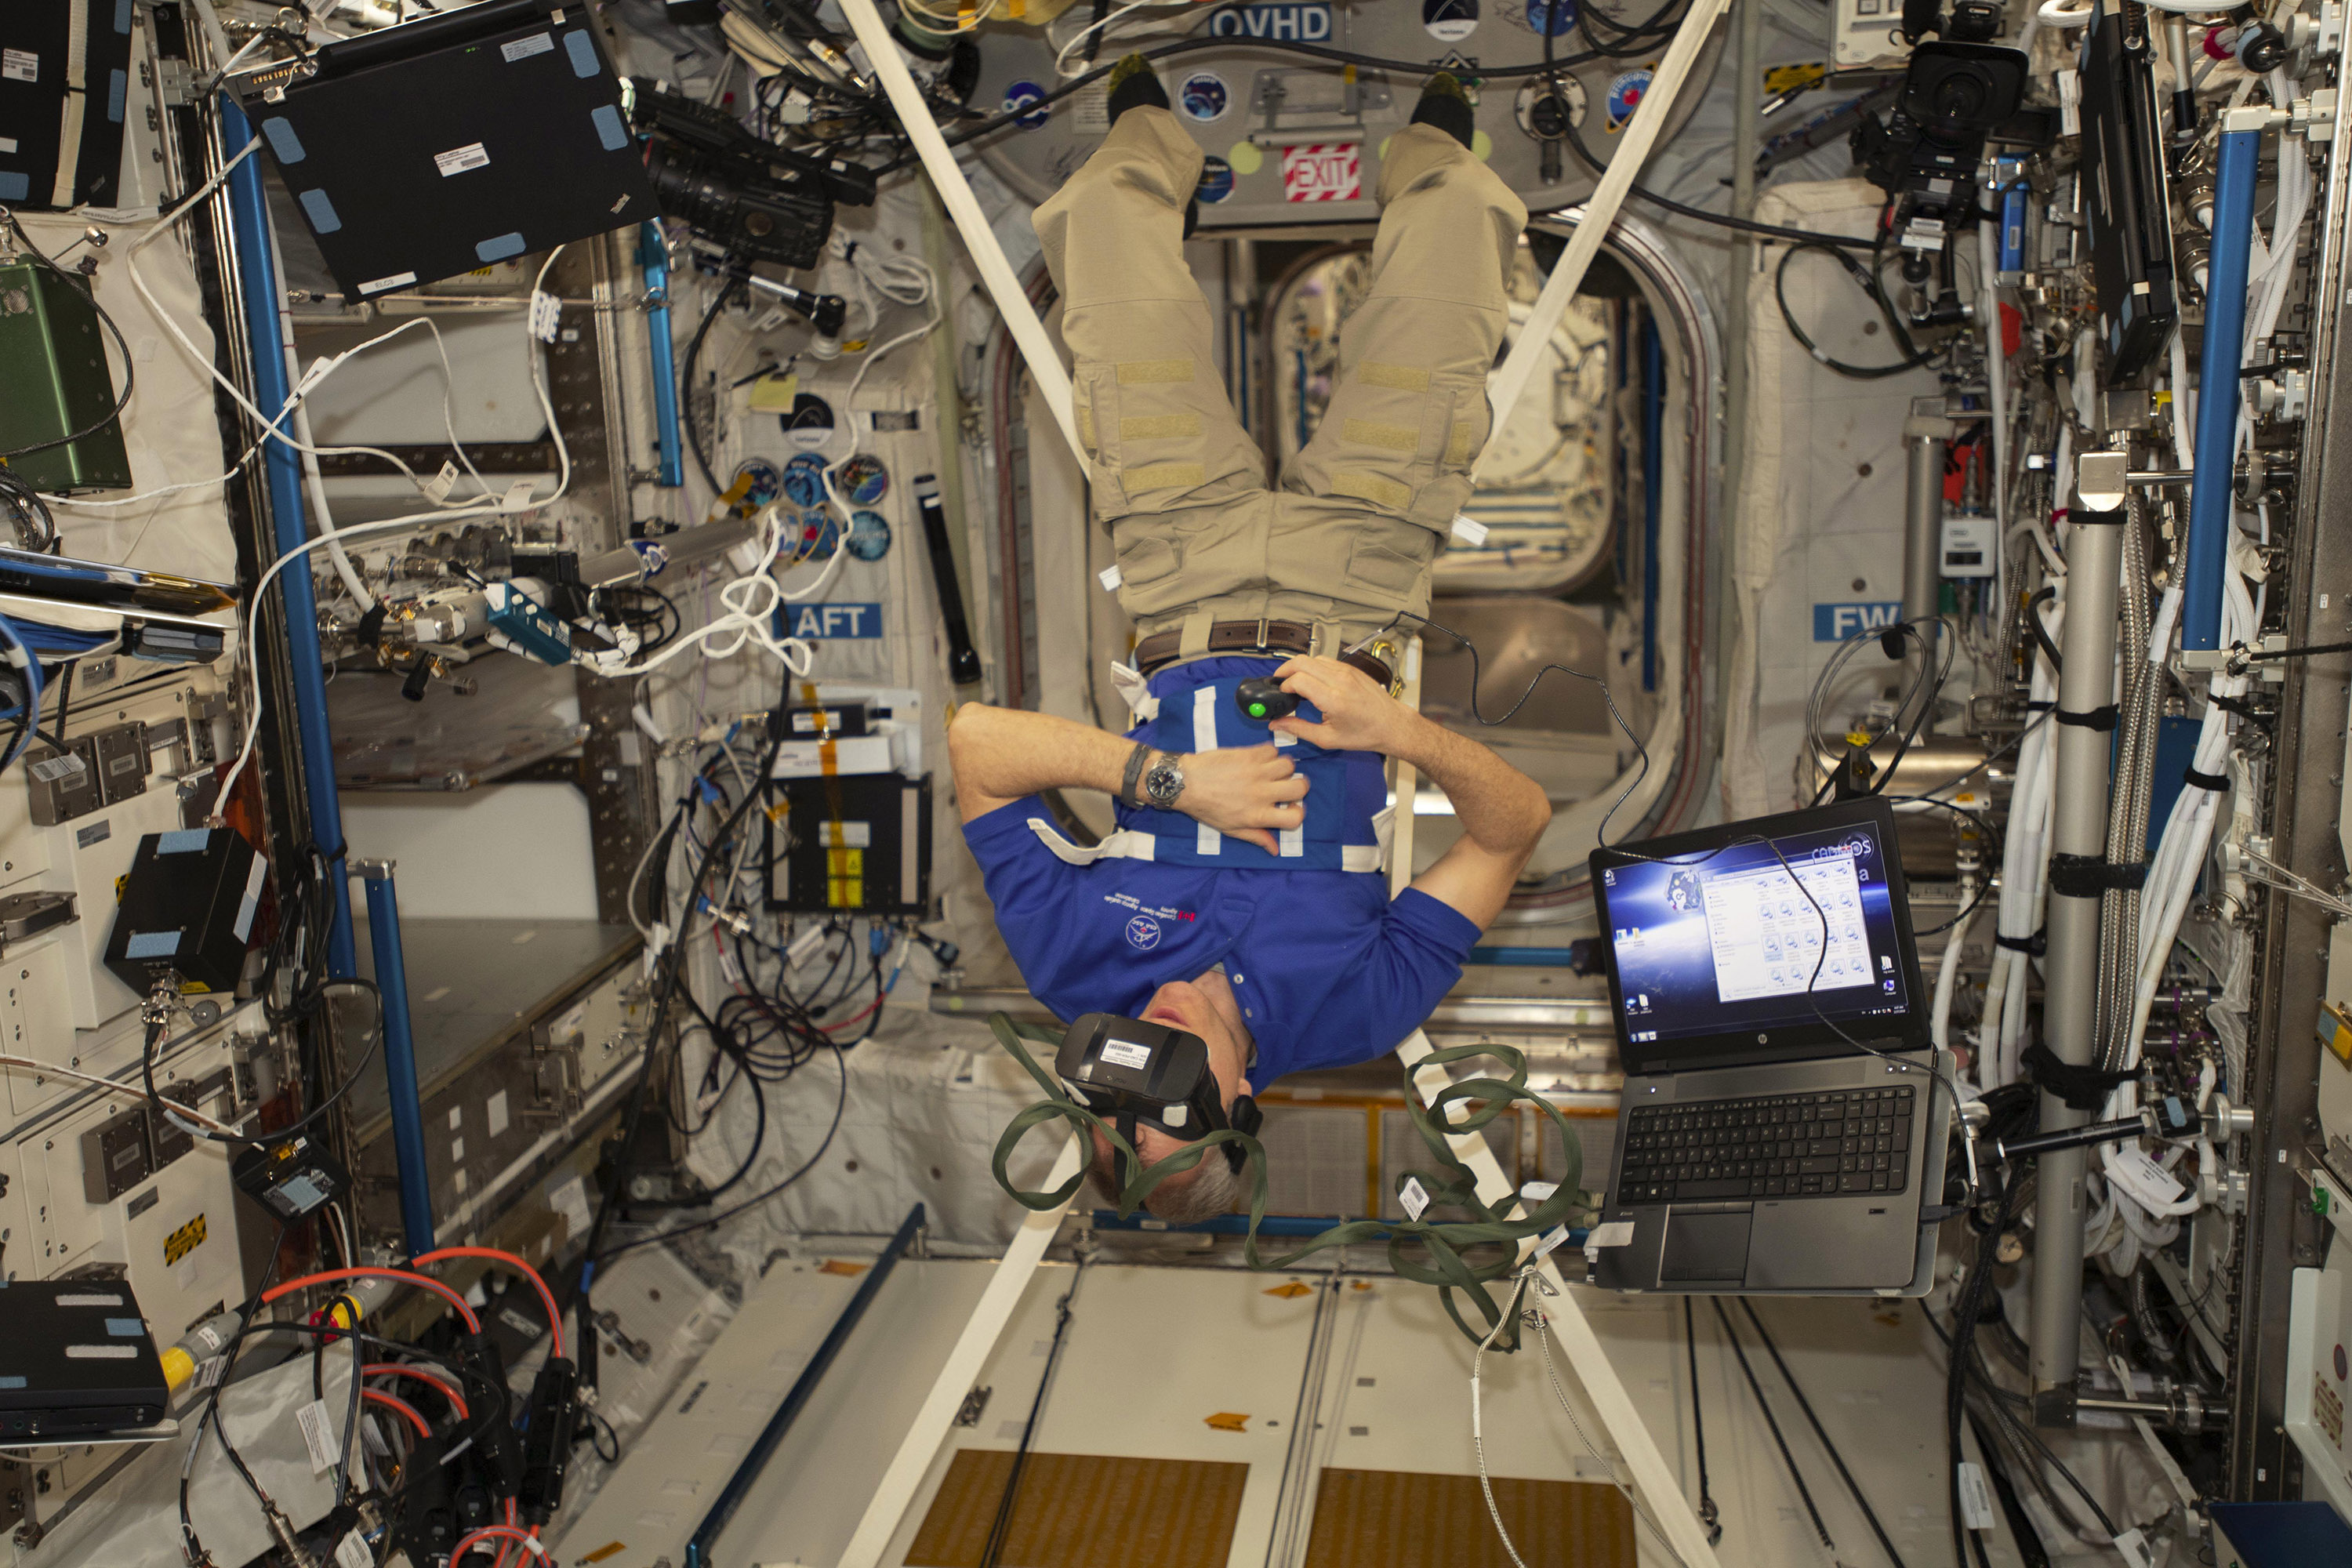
{"left": 2082, "top": 0, "right": 2180, "bottom": 383}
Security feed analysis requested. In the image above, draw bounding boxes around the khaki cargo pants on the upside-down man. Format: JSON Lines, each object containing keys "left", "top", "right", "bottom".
{"left": 1035, "top": 108, "right": 1526, "bottom": 656}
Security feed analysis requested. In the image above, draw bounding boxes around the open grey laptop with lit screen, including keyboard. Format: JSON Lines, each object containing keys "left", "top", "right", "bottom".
{"left": 1585, "top": 797, "right": 1950, "bottom": 1295}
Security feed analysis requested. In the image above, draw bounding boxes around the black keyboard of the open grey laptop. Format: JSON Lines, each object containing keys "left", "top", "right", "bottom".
{"left": 1616, "top": 1088, "right": 1912, "bottom": 1203}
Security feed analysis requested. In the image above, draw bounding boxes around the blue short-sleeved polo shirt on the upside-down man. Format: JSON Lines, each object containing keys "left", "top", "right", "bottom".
{"left": 964, "top": 659, "right": 1479, "bottom": 1091}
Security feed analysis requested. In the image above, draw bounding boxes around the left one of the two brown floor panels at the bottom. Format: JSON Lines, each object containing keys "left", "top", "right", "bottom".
{"left": 906, "top": 1448, "right": 1251, "bottom": 1568}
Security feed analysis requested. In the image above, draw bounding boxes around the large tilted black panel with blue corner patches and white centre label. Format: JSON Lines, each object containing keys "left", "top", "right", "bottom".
{"left": 240, "top": 0, "right": 656, "bottom": 303}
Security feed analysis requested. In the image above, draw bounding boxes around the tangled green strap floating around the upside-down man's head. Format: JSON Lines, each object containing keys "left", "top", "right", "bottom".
{"left": 988, "top": 1013, "right": 1583, "bottom": 1349}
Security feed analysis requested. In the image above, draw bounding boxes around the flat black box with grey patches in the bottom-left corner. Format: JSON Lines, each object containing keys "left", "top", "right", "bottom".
{"left": 0, "top": 1279, "right": 172, "bottom": 1443}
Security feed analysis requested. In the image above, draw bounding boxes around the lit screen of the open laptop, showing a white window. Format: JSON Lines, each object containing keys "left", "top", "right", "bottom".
{"left": 1592, "top": 799, "right": 1919, "bottom": 1072}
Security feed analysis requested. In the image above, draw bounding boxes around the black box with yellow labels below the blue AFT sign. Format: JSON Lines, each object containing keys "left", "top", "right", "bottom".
{"left": 767, "top": 774, "right": 931, "bottom": 914}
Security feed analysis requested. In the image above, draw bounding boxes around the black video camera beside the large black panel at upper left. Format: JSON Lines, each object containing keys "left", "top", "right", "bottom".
{"left": 628, "top": 78, "right": 875, "bottom": 268}
